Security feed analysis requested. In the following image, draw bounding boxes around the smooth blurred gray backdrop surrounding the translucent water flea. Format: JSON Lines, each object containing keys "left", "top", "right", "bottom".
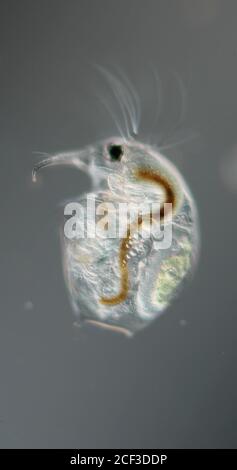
{"left": 0, "top": 0, "right": 237, "bottom": 448}
